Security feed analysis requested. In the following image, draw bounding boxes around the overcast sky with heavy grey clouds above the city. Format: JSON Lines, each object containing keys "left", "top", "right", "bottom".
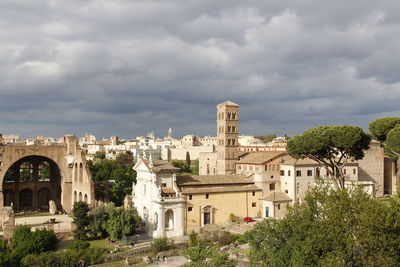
{"left": 0, "top": 0, "right": 400, "bottom": 138}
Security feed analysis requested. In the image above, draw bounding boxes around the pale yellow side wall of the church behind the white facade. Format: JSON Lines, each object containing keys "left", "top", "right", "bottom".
{"left": 185, "top": 191, "right": 262, "bottom": 234}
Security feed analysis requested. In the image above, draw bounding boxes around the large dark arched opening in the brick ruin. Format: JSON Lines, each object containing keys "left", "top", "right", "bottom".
{"left": 3, "top": 156, "right": 61, "bottom": 212}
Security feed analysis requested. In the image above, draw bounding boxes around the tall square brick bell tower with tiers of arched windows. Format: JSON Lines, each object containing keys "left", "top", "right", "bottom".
{"left": 217, "top": 101, "right": 239, "bottom": 174}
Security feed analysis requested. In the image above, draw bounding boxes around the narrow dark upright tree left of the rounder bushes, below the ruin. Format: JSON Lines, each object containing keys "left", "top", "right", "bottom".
{"left": 72, "top": 201, "right": 90, "bottom": 240}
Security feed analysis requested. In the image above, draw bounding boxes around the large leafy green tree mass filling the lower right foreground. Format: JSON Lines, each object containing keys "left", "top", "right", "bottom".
{"left": 246, "top": 185, "right": 400, "bottom": 266}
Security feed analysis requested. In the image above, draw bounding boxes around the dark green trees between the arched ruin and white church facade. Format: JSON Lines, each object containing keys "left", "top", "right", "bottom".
{"left": 87, "top": 154, "right": 136, "bottom": 206}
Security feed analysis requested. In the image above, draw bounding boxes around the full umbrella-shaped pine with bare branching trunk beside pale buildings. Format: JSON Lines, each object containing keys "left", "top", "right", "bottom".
{"left": 287, "top": 125, "right": 371, "bottom": 189}
